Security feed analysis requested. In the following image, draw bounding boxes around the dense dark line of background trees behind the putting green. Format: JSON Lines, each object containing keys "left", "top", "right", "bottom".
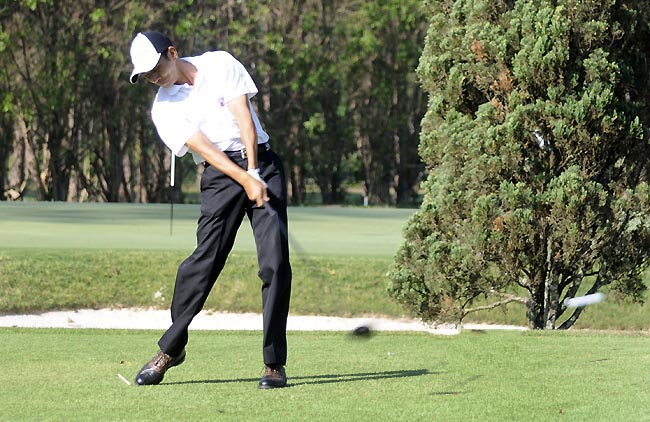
{"left": 0, "top": 0, "right": 426, "bottom": 205}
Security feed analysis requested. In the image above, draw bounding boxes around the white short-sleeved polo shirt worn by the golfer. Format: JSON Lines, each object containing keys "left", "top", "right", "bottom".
{"left": 151, "top": 51, "right": 269, "bottom": 164}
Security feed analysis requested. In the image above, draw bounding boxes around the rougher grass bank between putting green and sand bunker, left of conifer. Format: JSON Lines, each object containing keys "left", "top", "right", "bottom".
{"left": 0, "top": 249, "right": 404, "bottom": 316}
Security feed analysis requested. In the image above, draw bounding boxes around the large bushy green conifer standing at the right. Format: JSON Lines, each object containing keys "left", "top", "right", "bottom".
{"left": 390, "top": 0, "right": 650, "bottom": 329}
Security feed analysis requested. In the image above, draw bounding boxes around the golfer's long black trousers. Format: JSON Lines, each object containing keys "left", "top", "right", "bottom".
{"left": 158, "top": 150, "right": 291, "bottom": 365}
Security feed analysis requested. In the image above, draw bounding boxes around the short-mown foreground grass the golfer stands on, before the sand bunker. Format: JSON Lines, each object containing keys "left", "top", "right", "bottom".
{"left": 0, "top": 328, "right": 650, "bottom": 421}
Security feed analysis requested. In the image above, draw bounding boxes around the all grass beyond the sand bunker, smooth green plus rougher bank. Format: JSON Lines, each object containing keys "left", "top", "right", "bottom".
{"left": 0, "top": 202, "right": 650, "bottom": 330}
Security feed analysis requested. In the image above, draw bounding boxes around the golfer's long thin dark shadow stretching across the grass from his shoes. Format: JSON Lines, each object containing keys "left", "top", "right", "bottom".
{"left": 161, "top": 369, "right": 442, "bottom": 387}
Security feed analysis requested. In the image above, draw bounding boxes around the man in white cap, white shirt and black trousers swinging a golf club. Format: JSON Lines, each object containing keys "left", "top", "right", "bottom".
{"left": 131, "top": 31, "right": 291, "bottom": 389}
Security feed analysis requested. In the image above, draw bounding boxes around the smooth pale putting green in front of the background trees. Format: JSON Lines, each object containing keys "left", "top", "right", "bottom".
{"left": 0, "top": 202, "right": 414, "bottom": 256}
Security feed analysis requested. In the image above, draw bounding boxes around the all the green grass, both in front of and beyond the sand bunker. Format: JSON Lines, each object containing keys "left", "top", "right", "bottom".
{"left": 0, "top": 204, "right": 650, "bottom": 421}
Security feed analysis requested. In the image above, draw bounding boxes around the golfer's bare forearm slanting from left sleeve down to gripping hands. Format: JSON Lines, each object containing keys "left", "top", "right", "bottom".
{"left": 186, "top": 131, "right": 269, "bottom": 207}
